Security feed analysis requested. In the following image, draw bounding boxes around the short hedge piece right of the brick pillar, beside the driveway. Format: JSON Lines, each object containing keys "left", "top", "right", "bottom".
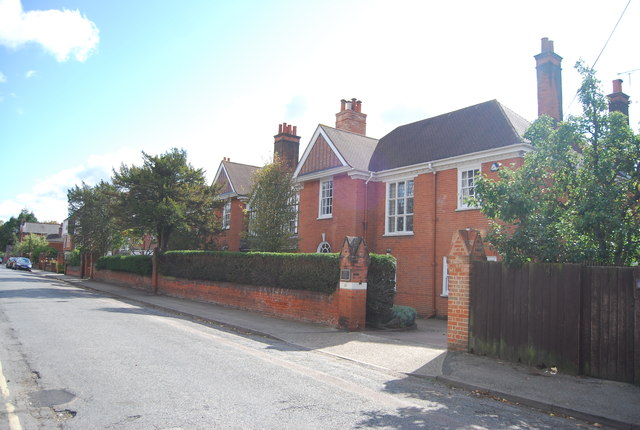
{"left": 367, "top": 254, "right": 396, "bottom": 326}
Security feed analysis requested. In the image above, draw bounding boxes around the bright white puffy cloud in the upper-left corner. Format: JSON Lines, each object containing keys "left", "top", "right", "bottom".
{"left": 0, "top": 0, "right": 100, "bottom": 62}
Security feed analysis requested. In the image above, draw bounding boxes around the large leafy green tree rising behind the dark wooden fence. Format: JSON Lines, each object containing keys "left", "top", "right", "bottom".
{"left": 477, "top": 62, "right": 640, "bottom": 265}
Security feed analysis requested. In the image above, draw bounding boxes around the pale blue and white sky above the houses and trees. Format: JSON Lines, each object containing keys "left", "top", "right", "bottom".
{"left": 0, "top": 0, "right": 640, "bottom": 222}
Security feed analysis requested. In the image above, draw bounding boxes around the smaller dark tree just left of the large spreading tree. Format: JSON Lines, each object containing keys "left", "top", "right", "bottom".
{"left": 67, "top": 181, "right": 122, "bottom": 255}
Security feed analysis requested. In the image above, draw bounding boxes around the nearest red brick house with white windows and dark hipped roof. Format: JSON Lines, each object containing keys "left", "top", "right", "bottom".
{"left": 216, "top": 38, "right": 600, "bottom": 316}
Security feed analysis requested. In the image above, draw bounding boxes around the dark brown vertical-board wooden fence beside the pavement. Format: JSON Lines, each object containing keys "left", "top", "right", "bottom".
{"left": 469, "top": 261, "right": 640, "bottom": 384}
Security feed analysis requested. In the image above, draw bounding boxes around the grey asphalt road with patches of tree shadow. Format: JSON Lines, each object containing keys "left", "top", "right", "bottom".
{"left": 0, "top": 266, "right": 586, "bottom": 430}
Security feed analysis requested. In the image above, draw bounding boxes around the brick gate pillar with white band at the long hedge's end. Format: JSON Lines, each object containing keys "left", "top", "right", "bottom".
{"left": 338, "top": 236, "right": 369, "bottom": 331}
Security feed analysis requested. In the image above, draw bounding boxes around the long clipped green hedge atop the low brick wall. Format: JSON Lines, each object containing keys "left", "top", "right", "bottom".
{"left": 158, "top": 251, "right": 340, "bottom": 294}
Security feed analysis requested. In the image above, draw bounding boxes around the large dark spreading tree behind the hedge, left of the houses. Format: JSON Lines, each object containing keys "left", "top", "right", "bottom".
{"left": 113, "top": 148, "right": 220, "bottom": 251}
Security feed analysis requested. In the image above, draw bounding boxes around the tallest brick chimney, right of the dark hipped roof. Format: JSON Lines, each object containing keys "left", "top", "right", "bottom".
{"left": 534, "top": 37, "right": 562, "bottom": 121}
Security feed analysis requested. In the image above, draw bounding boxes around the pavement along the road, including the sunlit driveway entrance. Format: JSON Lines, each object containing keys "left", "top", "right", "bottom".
{"left": 33, "top": 270, "right": 640, "bottom": 430}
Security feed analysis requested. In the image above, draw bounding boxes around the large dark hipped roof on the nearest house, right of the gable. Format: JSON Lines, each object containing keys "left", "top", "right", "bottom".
{"left": 368, "top": 100, "right": 529, "bottom": 172}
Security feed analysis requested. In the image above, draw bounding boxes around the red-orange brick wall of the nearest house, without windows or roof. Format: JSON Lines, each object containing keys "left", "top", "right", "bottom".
{"left": 299, "top": 158, "right": 522, "bottom": 317}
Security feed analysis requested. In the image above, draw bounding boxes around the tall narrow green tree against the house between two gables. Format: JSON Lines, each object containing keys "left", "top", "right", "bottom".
{"left": 246, "top": 158, "right": 298, "bottom": 252}
